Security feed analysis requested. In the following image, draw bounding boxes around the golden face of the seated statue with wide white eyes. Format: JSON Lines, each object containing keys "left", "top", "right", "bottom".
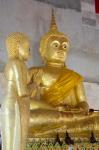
{"left": 45, "top": 36, "right": 69, "bottom": 64}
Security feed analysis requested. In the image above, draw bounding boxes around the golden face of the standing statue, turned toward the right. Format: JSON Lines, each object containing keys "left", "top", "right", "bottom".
{"left": 19, "top": 40, "right": 30, "bottom": 60}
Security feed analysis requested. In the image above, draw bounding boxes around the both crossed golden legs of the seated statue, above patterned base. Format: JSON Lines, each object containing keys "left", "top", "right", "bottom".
{"left": 29, "top": 109, "right": 99, "bottom": 137}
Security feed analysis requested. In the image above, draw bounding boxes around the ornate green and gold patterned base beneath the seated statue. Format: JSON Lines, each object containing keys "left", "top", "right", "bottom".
{"left": 26, "top": 139, "right": 99, "bottom": 150}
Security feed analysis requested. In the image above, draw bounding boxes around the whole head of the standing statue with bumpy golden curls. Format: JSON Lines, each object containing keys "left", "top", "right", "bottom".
{"left": 6, "top": 32, "right": 30, "bottom": 61}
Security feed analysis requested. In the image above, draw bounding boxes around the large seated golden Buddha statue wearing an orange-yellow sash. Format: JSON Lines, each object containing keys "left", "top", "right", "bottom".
{"left": 29, "top": 12, "right": 99, "bottom": 138}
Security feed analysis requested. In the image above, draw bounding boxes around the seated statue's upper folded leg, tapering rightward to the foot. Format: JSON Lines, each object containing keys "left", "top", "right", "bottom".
{"left": 29, "top": 109, "right": 73, "bottom": 137}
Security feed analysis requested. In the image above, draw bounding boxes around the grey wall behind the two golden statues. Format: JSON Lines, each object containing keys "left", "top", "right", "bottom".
{"left": 0, "top": 0, "right": 99, "bottom": 109}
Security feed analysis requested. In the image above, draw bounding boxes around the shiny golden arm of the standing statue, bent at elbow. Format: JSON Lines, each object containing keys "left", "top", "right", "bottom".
{"left": 13, "top": 60, "right": 28, "bottom": 97}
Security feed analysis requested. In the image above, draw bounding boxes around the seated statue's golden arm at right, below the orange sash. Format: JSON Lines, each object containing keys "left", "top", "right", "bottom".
{"left": 75, "top": 82, "right": 89, "bottom": 112}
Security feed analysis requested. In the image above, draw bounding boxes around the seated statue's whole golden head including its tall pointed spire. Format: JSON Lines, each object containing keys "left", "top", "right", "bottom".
{"left": 40, "top": 11, "right": 70, "bottom": 65}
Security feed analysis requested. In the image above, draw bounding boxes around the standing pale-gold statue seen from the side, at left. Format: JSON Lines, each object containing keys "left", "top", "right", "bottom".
{"left": 1, "top": 32, "right": 30, "bottom": 150}
